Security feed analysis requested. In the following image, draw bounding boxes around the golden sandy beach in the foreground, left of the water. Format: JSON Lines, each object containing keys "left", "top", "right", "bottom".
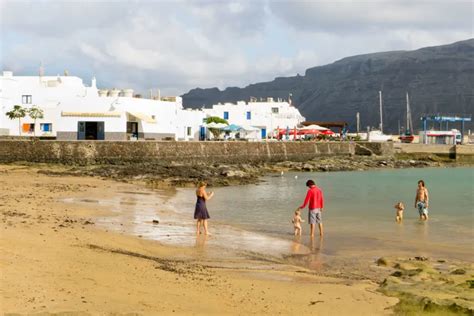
{"left": 0, "top": 165, "right": 398, "bottom": 315}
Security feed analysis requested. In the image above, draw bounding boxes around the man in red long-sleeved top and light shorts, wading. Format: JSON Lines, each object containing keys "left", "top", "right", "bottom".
{"left": 299, "top": 180, "right": 324, "bottom": 237}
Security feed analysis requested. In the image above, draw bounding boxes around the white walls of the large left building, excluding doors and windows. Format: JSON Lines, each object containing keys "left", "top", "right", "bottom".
{"left": 0, "top": 72, "right": 203, "bottom": 139}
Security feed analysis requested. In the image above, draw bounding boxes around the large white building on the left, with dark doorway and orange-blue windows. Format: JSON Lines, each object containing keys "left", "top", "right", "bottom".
{"left": 0, "top": 71, "right": 204, "bottom": 140}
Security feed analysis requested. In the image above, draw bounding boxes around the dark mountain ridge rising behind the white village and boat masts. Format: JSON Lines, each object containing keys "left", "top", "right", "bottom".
{"left": 182, "top": 39, "right": 474, "bottom": 133}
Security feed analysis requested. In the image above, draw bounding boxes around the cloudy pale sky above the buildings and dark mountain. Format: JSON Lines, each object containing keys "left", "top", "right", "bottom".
{"left": 0, "top": 0, "right": 474, "bottom": 95}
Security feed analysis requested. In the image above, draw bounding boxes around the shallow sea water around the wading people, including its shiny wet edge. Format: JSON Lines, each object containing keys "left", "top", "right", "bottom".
{"left": 92, "top": 167, "right": 474, "bottom": 262}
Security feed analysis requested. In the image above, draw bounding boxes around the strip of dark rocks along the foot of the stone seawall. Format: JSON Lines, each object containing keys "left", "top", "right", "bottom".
{"left": 10, "top": 155, "right": 473, "bottom": 189}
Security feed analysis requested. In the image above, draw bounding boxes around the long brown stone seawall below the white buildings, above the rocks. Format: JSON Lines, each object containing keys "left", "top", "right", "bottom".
{"left": 0, "top": 140, "right": 355, "bottom": 164}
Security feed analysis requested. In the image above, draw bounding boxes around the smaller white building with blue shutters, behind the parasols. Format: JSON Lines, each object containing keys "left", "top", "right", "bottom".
{"left": 203, "top": 98, "right": 305, "bottom": 138}
